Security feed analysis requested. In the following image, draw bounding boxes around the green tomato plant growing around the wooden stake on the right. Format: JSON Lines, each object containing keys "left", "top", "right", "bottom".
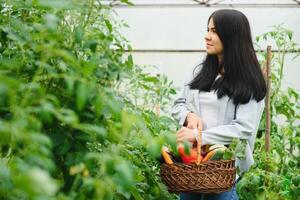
{"left": 237, "top": 25, "right": 300, "bottom": 199}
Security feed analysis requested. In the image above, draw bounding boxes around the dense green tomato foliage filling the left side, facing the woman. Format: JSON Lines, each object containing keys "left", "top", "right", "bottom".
{"left": 0, "top": 0, "right": 175, "bottom": 199}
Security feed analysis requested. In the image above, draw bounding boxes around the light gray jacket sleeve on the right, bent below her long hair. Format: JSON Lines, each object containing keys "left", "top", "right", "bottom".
{"left": 202, "top": 99, "right": 265, "bottom": 145}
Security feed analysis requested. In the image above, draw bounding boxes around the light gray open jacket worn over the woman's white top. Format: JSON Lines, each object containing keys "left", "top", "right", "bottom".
{"left": 171, "top": 66, "right": 265, "bottom": 172}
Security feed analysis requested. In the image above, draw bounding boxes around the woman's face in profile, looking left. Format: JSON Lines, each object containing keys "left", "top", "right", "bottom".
{"left": 204, "top": 18, "right": 223, "bottom": 60}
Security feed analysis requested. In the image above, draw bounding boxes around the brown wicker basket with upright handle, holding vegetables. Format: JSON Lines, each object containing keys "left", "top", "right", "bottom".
{"left": 160, "top": 130, "right": 236, "bottom": 193}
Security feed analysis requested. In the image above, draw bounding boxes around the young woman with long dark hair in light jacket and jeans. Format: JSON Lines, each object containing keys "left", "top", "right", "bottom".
{"left": 172, "top": 9, "right": 266, "bottom": 200}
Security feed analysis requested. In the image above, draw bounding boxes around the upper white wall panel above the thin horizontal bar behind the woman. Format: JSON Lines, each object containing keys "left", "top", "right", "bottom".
{"left": 115, "top": 7, "right": 300, "bottom": 50}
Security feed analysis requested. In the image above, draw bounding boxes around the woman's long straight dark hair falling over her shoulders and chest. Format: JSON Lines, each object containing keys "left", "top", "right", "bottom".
{"left": 189, "top": 9, "right": 266, "bottom": 105}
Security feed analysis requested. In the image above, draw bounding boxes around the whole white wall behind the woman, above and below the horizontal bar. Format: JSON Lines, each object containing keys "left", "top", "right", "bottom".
{"left": 115, "top": 6, "right": 300, "bottom": 91}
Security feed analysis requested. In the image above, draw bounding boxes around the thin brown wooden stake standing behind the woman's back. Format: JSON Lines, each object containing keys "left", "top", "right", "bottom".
{"left": 265, "top": 45, "right": 272, "bottom": 153}
